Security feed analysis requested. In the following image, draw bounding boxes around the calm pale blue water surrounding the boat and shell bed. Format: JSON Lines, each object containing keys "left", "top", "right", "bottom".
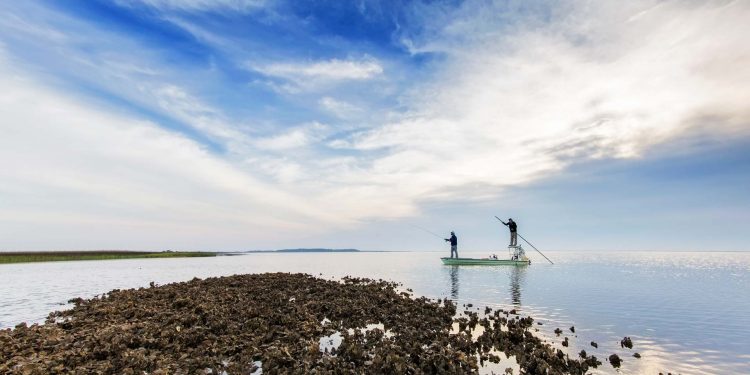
{"left": 0, "top": 252, "right": 750, "bottom": 374}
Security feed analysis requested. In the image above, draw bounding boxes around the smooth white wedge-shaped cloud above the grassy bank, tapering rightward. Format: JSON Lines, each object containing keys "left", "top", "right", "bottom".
{"left": 0, "top": 61, "right": 338, "bottom": 249}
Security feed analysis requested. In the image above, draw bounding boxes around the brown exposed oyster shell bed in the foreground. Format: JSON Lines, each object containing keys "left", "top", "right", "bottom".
{"left": 0, "top": 273, "right": 601, "bottom": 374}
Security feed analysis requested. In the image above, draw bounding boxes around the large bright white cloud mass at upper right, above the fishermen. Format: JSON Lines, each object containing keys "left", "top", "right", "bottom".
{"left": 316, "top": 2, "right": 750, "bottom": 220}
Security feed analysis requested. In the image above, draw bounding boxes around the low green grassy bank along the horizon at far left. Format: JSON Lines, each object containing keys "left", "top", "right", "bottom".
{"left": 0, "top": 251, "right": 216, "bottom": 264}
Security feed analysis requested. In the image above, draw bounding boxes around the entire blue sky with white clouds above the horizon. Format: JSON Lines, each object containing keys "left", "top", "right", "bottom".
{"left": 0, "top": 0, "right": 750, "bottom": 251}
